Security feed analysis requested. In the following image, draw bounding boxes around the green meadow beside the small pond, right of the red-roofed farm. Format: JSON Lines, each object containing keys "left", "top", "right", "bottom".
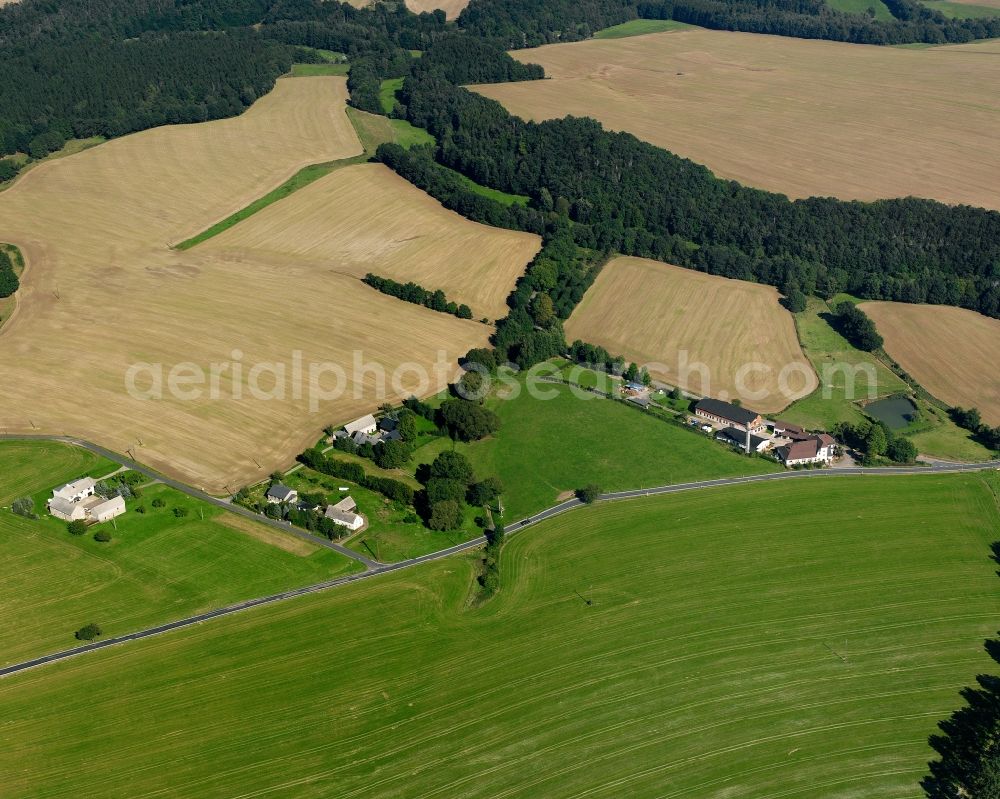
{"left": 779, "top": 297, "right": 908, "bottom": 430}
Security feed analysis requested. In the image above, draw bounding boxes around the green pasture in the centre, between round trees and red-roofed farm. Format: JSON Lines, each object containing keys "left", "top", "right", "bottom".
{"left": 415, "top": 384, "right": 780, "bottom": 521}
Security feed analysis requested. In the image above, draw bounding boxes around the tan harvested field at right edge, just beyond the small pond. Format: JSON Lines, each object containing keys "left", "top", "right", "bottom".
{"left": 861, "top": 302, "right": 1000, "bottom": 425}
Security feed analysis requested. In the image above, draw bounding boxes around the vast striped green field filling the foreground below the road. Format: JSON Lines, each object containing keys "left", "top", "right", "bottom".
{"left": 0, "top": 475, "right": 1000, "bottom": 799}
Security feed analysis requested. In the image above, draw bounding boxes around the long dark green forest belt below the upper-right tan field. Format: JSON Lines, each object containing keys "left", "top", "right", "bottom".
{"left": 390, "top": 75, "right": 1000, "bottom": 316}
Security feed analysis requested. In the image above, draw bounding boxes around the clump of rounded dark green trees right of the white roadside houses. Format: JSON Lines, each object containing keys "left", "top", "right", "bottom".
{"left": 417, "top": 452, "right": 503, "bottom": 530}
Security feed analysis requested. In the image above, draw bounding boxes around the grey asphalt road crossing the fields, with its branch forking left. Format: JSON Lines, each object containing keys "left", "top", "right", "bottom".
{"left": 0, "top": 434, "right": 1000, "bottom": 677}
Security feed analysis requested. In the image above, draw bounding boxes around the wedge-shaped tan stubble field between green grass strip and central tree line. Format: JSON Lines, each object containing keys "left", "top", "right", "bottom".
{"left": 199, "top": 164, "right": 541, "bottom": 319}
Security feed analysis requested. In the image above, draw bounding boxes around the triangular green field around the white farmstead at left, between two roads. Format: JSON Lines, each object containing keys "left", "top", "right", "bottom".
{"left": 0, "top": 442, "right": 357, "bottom": 664}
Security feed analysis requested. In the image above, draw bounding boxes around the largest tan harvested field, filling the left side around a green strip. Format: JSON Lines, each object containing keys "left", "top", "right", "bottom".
{"left": 0, "top": 77, "right": 487, "bottom": 492}
